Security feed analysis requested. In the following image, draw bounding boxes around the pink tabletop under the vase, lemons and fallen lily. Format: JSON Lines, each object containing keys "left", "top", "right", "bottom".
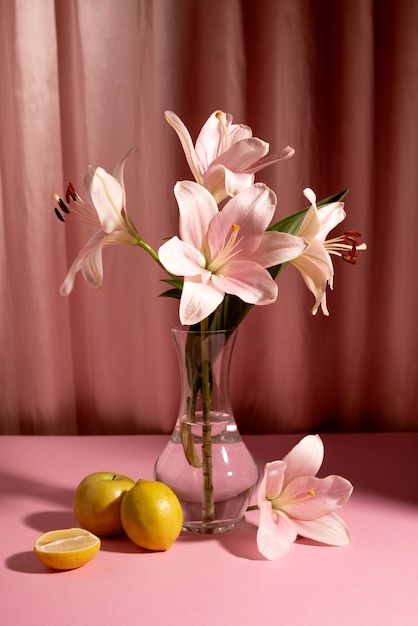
{"left": 0, "top": 433, "right": 418, "bottom": 626}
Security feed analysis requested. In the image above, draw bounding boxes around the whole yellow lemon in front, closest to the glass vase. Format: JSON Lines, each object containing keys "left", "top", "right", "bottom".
{"left": 121, "top": 480, "right": 183, "bottom": 550}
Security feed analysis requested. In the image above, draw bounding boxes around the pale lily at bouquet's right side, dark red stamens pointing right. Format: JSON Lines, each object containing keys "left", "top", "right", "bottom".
{"left": 291, "top": 188, "right": 367, "bottom": 315}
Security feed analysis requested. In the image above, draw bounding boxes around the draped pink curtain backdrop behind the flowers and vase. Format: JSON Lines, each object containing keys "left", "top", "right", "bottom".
{"left": 0, "top": 0, "right": 418, "bottom": 434}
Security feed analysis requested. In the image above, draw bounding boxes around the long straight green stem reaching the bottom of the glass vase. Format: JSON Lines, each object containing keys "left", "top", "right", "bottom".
{"left": 200, "top": 319, "right": 215, "bottom": 524}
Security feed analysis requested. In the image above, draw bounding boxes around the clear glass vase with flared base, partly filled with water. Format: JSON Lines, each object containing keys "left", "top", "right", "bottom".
{"left": 154, "top": 327, "right": 259, "bottom": 533}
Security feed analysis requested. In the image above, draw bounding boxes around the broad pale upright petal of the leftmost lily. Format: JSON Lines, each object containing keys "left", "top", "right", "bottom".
{"left": 90, "top": 167, "right": 124, "bottom": 233}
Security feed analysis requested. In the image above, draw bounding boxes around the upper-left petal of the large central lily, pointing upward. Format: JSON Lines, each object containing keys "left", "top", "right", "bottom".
{"left": 174, "top": 180, "right": 218, "bottom": 250}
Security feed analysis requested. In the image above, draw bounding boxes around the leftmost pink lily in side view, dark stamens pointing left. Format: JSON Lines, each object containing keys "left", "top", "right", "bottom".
{"left": 53, "top": 150, "right": 139, "bottom": 296}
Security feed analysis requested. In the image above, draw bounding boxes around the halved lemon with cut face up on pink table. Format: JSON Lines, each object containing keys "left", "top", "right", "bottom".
{"left": 33, "top": 528, "right": 100, "bottom": 570}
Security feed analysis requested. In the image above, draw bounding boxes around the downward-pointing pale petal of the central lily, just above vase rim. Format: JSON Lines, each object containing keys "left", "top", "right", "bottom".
{"left": 180, "top": 277, "right": 225, "bottom": 325}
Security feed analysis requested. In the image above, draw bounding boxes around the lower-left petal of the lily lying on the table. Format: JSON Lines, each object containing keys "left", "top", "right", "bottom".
{"left": 257, "top": 501, "right": 297, "bottom": 560}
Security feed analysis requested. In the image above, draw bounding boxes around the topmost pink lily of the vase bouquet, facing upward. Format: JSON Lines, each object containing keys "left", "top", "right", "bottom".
{"left": 165, "top": 111, "right": 295, "bottom": 202}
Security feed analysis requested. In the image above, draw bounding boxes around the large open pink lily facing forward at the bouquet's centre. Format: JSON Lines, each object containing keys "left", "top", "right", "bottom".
{"left": 158, "top": 181, "right": 306, "bottom": 325}
